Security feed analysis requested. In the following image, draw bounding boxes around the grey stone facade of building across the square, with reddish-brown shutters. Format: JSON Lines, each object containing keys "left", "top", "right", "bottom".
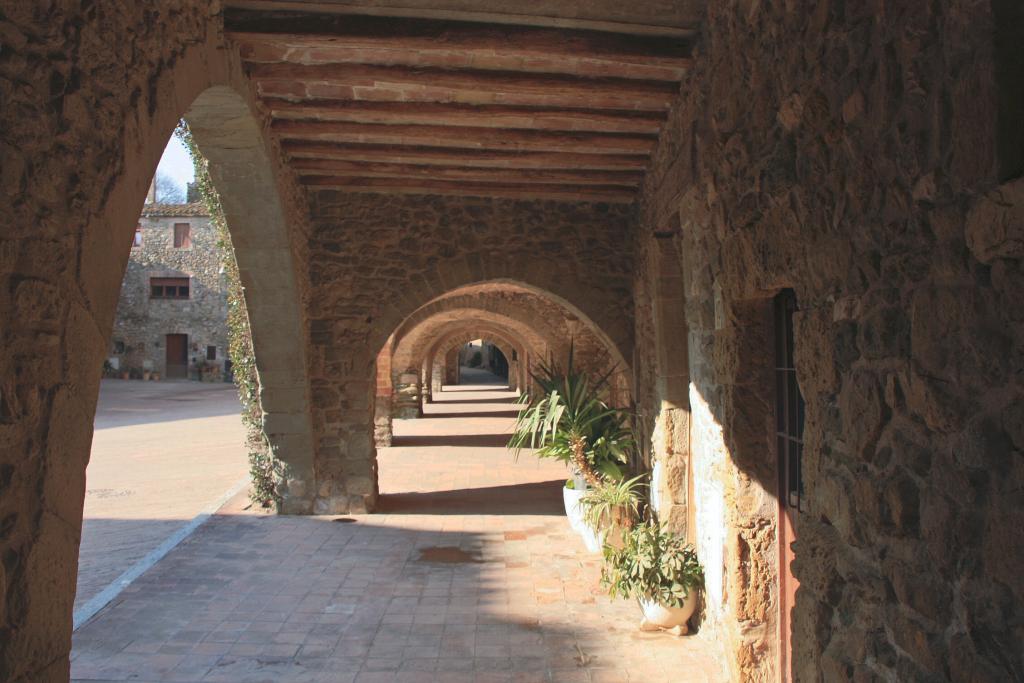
{"left": 111, "top": 205, "right": 227, "bottom": 378}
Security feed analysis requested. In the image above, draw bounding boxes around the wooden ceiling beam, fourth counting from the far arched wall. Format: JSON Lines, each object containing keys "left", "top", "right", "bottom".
{"left": 270, "top": 121, "right": 657, "bottom": 154}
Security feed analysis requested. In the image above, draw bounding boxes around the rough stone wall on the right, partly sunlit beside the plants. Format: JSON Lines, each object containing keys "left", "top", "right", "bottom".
{"left": 637, "top": 1, "right": 1024, "bottom": 681}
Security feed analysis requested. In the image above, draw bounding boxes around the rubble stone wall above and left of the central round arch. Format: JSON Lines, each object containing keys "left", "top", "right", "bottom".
{"left": 307, "top": 190, "right": 635, "bottom": 513}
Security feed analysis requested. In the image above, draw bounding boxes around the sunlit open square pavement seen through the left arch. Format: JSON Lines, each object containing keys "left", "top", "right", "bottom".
{"left": 75, "top": 380, "right": 249, "bottom": 609}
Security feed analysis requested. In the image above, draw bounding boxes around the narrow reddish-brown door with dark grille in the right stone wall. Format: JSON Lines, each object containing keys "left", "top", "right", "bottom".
{"left": 775, "top": 290, "right": 804, "bottom": 683}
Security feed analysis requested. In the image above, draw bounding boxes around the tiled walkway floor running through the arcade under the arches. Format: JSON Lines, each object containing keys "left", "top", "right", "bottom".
{"left": 72, "top": 378, "right": 723, "bottom": 683}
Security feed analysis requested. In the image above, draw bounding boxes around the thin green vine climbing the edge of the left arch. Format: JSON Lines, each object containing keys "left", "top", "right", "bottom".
{"left": 174, "top": 121, "right": 282, "bottom": 508}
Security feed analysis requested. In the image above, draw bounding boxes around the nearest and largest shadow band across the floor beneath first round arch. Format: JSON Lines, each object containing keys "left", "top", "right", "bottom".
{"left": 377, "top": 479, "right": 565, "bottom": 515}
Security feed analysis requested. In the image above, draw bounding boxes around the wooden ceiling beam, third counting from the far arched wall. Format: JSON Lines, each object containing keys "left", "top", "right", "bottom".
{"left": 282, "top": 140, "right": 650, "bottom": 171}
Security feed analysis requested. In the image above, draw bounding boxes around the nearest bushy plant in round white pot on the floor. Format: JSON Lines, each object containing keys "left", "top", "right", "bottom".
{"left": 601, "top": 518, "right": 703, "bottom": 636}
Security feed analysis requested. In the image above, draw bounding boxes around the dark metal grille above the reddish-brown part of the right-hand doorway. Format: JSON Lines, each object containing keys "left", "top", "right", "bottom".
{"left": 775, "top": 290, "right": 805, "bottom": 511}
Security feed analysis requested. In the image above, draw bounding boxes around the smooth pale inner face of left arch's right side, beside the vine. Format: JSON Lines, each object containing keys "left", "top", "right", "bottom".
{"left": 184, "top": 85, "right": 313, "bottom": 513}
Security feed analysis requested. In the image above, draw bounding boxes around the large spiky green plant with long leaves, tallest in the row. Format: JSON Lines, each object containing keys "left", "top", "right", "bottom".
{"left": 509, "top": 346, "right": 634, "bottom": 486}
